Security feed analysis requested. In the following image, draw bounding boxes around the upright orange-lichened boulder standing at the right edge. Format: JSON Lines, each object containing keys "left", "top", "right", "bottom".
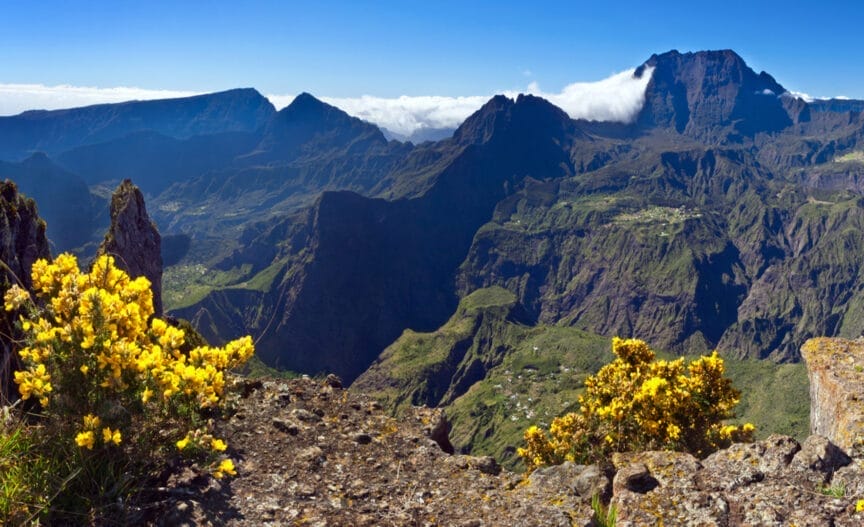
{"left": 801, "top": 338, "right": 864, "bottom": 457}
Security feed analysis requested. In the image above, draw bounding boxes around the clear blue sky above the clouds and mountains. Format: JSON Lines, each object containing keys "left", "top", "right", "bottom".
{"left": 0, "top": 0, "right": 864, "bottom": 131}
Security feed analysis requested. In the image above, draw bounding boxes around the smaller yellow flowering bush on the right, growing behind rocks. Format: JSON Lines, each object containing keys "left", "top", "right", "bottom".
{"left": 518, "top": 337, "right": 754, "bottom": 471}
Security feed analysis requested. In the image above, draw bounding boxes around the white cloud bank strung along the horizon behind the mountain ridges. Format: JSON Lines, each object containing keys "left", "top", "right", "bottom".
{"left": 0, "top": 69, "right": 651, "bottom": 136}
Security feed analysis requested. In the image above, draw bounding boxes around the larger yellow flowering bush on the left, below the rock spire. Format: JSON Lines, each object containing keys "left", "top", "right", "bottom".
{"left": 5, "top": 254, "right": 254, "bottom": 520}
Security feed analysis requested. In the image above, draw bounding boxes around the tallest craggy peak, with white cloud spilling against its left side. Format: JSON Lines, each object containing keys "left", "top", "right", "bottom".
{"left": 635, "top": 49, "right": 792, "bottom": 140}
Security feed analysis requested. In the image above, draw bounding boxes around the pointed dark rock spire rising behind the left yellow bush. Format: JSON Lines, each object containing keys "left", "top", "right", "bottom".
{"left": 97, "top": 179, "right": 162, "bottom": 316}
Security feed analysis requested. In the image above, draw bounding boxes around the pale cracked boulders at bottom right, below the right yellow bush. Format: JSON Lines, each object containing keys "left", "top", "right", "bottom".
{"left": 611, "top": 435, "right": 864, "bottom": 527}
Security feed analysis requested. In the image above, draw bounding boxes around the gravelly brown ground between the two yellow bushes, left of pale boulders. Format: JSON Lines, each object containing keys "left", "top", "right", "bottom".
{"left": 150, "top": 378, "right": 608, "bottom": 527}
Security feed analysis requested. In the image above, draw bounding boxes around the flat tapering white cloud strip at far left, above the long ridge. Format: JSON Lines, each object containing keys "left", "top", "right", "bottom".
{"left": 0, "top": 84, "right": 198, "bottom": 115}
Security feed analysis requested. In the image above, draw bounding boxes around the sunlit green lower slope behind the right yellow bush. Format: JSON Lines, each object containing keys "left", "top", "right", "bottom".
{"left": 352, "top": 287, "right": 810, "bottom": 468}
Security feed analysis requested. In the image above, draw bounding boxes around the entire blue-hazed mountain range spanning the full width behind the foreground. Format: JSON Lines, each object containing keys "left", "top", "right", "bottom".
{"left": 0, "top": 50, "right": 864, "bottom": 394}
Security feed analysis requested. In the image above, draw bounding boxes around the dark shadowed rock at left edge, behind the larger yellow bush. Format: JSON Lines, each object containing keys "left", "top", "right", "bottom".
{"left": 0, "top": 181, "right": 51, "bottom": 401}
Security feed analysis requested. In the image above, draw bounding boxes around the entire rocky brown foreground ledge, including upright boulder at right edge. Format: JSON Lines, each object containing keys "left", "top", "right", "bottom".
{"left": 150, "top": 339, "right": 864, "bottom": 527}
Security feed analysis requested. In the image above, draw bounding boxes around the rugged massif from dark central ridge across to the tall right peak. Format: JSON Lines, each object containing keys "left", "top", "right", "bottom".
{"left": 162, "top": 51, "right": 864, "bottom": 390}
